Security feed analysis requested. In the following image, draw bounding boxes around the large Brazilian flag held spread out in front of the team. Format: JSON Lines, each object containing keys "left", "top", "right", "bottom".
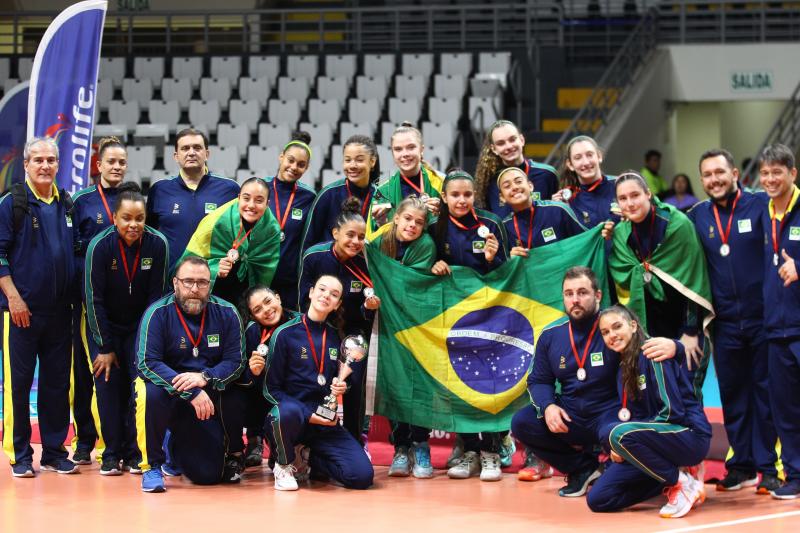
{"left": 367, "top": 227, "right": 606, "bottom": 433}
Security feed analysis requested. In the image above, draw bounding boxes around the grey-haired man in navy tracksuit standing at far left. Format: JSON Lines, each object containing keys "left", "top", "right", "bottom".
{"left": 0, "top": 139, "right": 76, "bottom": 477}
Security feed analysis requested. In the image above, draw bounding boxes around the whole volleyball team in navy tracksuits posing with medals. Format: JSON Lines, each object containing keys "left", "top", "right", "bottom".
{"left": 0, "top": 120, "right": 800, "bottom": 518}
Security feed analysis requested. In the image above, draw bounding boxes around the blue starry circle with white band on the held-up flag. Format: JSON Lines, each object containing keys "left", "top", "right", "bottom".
{"left": 447, "top": 306, "right": 533, "bottom": 394}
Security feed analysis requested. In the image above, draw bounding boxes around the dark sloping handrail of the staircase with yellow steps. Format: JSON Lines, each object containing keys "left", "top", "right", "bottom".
{"left": 545, "top": 8, "right": 658, "bottom": 165}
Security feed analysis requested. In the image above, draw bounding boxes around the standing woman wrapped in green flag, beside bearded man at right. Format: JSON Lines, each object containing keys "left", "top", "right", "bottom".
{"left": 609, "top": 172, "right": 714, "bottom": 396}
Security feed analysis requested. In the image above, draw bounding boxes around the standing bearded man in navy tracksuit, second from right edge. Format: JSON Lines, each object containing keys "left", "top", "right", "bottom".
{"left": 687, "top": 151, "right": 778, "bottom": 494}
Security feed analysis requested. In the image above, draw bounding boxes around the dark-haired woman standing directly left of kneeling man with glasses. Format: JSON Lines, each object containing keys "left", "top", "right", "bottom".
{"left": 84, "top": 200, "right": 168, "bottom": 475}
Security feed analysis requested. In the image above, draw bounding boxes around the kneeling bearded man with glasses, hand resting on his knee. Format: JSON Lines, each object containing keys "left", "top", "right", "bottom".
{"left": 135, "top": 257, "right": 246, "bottom": 492}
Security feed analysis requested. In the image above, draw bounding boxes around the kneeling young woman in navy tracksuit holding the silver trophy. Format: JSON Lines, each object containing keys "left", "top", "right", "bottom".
{"left": 264, "top": 275, "right": 373, "bottom": 490}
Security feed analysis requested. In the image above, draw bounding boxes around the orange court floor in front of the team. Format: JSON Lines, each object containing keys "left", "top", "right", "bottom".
{"left": 0, "top": 446, "right": 800, "bottom": 533}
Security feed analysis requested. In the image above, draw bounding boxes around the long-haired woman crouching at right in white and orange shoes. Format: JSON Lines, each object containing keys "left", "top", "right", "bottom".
{"left": 587, "top": 305, "right": 711, "bottom": 518}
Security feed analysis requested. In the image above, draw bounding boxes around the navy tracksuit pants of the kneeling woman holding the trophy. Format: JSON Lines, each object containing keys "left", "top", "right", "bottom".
{"left": 266, "top": 398, "right": 374, "bottom": 489}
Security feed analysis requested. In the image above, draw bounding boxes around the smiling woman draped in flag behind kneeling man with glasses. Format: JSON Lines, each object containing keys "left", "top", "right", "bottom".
{"left": 178, "top": 177, "right": 281, "bottom": 304}
